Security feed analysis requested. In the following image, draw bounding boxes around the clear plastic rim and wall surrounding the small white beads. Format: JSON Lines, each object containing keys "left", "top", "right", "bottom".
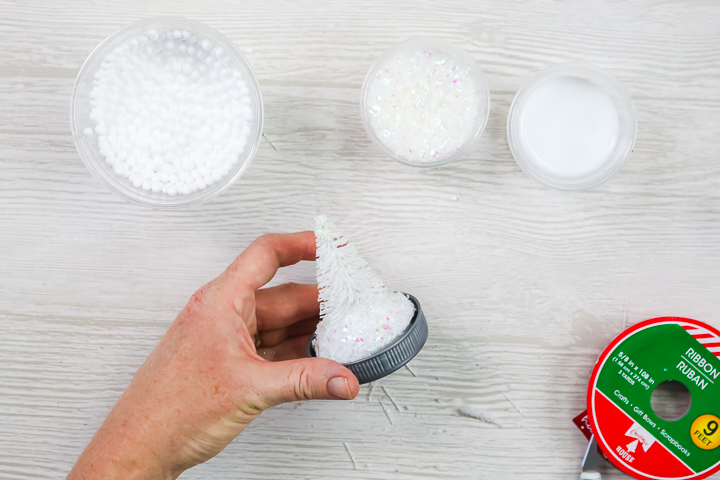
{"left": 70, "top": 17, "right": 263, "bottom": 210}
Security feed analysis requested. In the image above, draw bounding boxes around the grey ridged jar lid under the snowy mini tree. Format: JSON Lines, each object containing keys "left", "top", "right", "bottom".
{"left": 307, "top": 293, "right": 428, "bottom": 385}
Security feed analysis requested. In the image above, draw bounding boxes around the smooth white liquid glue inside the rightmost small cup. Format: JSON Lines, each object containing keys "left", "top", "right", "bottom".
{"left": 517, "top": 76, "right": 619, "bottom": 178}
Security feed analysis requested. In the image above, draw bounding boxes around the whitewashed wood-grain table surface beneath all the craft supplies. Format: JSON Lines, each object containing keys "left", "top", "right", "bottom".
{"left": 0, "top": 0, "right": 720, "bottom": 479}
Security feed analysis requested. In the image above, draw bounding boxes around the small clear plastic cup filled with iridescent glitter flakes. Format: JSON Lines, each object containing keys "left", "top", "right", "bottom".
{"left": 360, "top": 38, "right": 490, "bottom": 167}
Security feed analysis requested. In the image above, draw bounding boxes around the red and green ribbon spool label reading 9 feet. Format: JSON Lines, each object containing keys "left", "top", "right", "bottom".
{"left": 588, "top": 317, "right": 720, "bottom": 480}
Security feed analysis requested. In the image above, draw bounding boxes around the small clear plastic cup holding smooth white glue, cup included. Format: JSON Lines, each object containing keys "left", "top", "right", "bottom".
{"left": 507, "top": 63, "right": 637, "bottom": 190}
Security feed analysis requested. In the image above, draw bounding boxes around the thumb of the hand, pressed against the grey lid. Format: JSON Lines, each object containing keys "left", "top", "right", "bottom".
{"left": 263, "top": 358, "right": 360, "bottom": 406}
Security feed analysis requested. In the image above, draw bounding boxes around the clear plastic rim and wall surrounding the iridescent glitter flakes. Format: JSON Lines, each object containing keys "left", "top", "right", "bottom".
{"left": 360, "top": 38, "right": 490, "bottom": 167}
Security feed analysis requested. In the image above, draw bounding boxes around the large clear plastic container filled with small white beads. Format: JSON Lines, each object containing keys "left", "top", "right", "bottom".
{"left": 70, "top": 17, "right": 263, "bottom": 210}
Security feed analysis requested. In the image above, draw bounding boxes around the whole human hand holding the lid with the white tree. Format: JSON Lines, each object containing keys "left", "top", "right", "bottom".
{"left": 68, "top": 232, "right": 359, "bottom": 480}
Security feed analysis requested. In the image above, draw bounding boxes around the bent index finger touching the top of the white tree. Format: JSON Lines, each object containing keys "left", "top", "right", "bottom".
{"left": 223, "top": 231, "right": 315, "bottom": 290}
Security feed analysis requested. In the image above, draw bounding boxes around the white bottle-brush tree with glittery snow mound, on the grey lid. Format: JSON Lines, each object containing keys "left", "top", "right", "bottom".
{"left": 313, "top": 215, "right": 415, "bottom": 363}
